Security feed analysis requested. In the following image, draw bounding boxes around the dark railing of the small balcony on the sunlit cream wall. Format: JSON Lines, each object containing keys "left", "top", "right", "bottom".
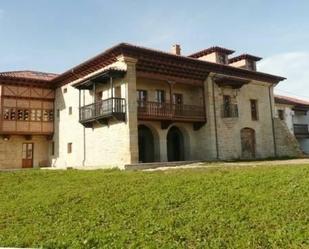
{"left": 79, "top": 98, "right": 126, "bottom": 122}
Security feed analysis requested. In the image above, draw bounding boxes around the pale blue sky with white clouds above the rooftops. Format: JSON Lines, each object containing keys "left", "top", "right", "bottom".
{"left": 0, "top": 0, "right": 309, "bottom": 99}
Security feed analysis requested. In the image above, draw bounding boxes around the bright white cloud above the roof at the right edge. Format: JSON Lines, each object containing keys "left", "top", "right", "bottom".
{"left": 258, "top": 52, "right": 309, "bottom": 99}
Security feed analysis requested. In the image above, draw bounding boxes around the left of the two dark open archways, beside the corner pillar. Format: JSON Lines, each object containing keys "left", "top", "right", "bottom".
{"left": 138, "top": 125, "right": 154, "bottom": 163}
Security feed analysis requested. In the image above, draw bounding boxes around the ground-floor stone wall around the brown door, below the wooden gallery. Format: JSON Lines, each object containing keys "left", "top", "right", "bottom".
{"left": 0, "top": 135, "right": 51, "bottom": 169}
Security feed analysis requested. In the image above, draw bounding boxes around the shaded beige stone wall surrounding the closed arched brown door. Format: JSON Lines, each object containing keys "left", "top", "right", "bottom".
{"left": 201, "top": 76, "right": 274, "bottom": 160}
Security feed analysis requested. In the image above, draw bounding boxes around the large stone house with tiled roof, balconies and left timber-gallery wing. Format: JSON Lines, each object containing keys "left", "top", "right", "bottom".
{"left": 0, "top": 43, "right": 298, "bottom": 168}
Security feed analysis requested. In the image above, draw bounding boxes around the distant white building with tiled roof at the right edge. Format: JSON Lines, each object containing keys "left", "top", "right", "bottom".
{"left": 275, "top": 95, "right": 309, "bottom": 154}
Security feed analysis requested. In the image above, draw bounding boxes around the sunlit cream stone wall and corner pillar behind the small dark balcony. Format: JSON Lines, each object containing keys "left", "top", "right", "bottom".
{"left": 51, "top": 58, "right": 138, "bottom": 167}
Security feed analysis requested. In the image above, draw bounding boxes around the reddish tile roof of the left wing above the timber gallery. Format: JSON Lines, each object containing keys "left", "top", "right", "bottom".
{"left": 0, "top": 70, "right": 58, "bottom": 81}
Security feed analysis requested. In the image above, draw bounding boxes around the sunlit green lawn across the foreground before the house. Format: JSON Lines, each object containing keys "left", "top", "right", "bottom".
{"left": 0, "top": 166, "right": 309, "bottom": 249}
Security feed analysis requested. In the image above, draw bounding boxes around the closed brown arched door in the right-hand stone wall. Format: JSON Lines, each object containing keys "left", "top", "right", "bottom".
{"left": 240, "top": 128, "right": 255, "bottom": 159}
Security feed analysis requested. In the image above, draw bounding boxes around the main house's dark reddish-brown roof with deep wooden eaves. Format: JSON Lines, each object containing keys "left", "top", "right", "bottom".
{"left": 52, "top": 43, "right": 285, "bottom": 86}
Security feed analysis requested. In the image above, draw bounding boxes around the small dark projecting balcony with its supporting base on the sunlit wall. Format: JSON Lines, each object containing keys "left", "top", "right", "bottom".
{"left": 79, "top": 98, "right": 126, "bottom": 127}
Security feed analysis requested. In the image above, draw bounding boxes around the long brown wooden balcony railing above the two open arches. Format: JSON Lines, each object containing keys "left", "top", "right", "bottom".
{"left": 137, "top": 101, "right": 206, "bottom": 122}
